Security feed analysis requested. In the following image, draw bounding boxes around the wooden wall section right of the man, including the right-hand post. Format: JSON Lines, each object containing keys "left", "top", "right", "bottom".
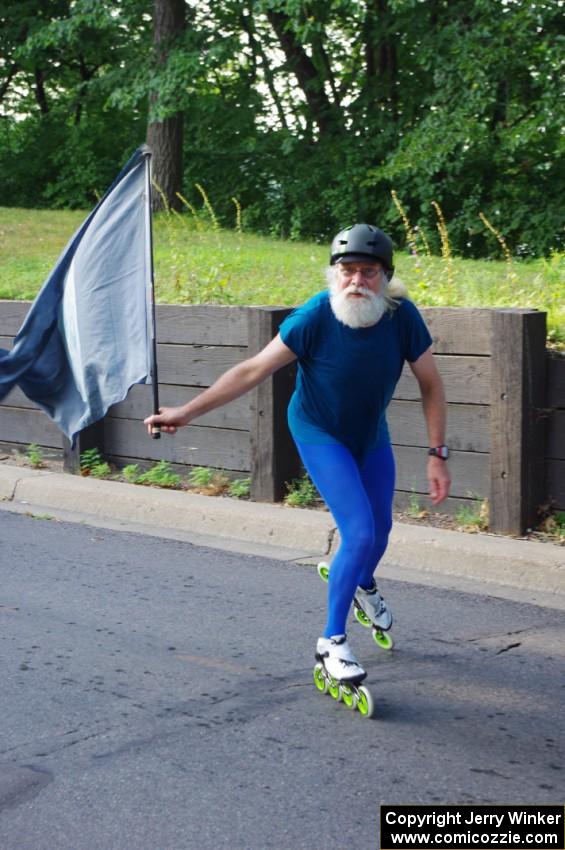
{"left": 389, "top": 308, "right": 546, "bottom": 533}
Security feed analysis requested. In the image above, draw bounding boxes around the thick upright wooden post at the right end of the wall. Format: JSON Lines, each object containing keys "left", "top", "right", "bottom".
{"left": 490, "top": 310, "right": 545, "bottom": 534}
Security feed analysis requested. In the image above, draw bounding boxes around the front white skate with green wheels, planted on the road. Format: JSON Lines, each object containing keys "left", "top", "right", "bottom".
{"left": 314, "top": 635, "right": 374, "bottom": 717}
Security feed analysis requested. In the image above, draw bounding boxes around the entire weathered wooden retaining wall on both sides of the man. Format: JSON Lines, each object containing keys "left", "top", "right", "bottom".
{"left": 0, "top": 301, "right": 565, "bottom": 533}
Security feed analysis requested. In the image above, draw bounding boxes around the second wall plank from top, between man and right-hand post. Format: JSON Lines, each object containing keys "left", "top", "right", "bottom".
{"left": 394, "top": 354, "right": 491, "bottom": 404}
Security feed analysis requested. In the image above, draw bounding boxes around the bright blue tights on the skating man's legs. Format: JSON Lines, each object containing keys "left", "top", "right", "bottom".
{"left": 297, "top": 442, "right": 395, "bottom": 637}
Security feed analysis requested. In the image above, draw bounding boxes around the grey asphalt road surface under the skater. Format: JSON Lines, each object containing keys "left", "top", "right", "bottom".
{"left": 0, "top": 511, "right": 565, "bottom": 850}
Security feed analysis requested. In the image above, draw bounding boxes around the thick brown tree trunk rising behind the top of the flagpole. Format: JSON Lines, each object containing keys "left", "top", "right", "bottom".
{"left": 147, "top": 0, "right": 185, "bottom": 210}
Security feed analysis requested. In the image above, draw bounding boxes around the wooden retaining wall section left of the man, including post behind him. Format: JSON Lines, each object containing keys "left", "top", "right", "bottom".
{"left": 0, "top": 301, "right": 301, "bottom": 501}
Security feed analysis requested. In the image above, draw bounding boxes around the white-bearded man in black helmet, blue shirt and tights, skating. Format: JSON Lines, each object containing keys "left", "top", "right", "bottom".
{"left": 145, "top": 224, "right": 450, "bottom": 696}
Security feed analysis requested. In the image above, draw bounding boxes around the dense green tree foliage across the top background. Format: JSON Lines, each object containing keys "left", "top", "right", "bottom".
{"left": 0, "top": 0, "right": 565, "bottom": 256}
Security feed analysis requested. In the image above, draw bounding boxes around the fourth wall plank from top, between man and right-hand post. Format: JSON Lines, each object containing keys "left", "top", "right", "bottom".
{"left": 393, "top": 446, "right": 489, "bottom": 499}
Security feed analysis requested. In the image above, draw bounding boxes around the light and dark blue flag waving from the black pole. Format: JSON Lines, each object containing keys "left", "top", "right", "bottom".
{"left": 0, "top": 146, "right": 153, "bottom": 445}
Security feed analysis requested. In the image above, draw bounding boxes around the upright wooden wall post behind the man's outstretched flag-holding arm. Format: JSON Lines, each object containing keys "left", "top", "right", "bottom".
{"left": 248, "top": 307, "right": 301, "bottom": 502}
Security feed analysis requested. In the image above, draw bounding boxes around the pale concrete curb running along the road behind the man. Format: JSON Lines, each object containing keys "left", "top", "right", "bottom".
{"left": 0, "top": 464, "right": 565, "bottom": 596}
